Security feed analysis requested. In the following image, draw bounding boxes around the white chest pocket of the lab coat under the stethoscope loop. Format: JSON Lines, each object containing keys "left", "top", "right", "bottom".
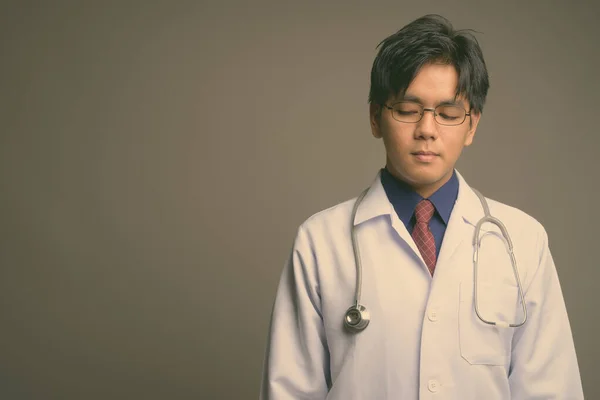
{"left": 458, "top": 282, "right": 519, "bottom": 365}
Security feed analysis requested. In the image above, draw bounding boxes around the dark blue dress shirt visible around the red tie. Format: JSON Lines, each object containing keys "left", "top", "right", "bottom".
{"left": 381, "top": 168, "right": 458, "bottom": 258}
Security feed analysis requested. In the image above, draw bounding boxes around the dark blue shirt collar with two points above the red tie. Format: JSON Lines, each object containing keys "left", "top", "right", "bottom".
{"left": 381, "top": 168, "right": 459, "bottom": 225}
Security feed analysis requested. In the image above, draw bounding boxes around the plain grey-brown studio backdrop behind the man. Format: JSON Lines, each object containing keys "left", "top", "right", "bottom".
{"left": 0, "top": 1, "right": 600, "bottom": 399}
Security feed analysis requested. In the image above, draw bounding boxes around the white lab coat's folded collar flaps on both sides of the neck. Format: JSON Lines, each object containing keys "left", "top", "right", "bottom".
{"left": 354, "top": 170, "right": 484, "bottom": 225}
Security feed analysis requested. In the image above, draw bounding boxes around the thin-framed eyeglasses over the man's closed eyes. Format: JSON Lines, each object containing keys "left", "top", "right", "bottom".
{"left": 383, "top": 101, "right": 471, "bottom": 126}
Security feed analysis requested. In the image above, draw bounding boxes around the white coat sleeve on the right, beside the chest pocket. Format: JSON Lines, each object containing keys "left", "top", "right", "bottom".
{"left": 509, "top": 228, "right": 583, "bottom": 400}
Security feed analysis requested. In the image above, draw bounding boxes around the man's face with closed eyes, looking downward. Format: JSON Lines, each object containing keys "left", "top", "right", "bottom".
{"left": 370, "top": 64, "right": 480, "bottom": 197}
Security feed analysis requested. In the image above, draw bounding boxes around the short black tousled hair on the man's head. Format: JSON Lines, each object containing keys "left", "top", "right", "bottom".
{"left": 369, "top": 14, "right": 490, "bottom": 113}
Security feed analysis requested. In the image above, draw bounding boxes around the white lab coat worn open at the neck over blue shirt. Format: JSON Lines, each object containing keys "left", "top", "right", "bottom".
{"left": 260, "top": 173, "right": 583, "bottom": 400}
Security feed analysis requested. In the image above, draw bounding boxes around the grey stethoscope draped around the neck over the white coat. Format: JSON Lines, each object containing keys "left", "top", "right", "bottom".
{"left": 344, "top": 188, "right": 527, "bottom": 333}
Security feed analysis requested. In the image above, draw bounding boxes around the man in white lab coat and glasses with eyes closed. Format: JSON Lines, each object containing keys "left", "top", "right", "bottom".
{"left": 261, "top": 15, "right": 583, "bottom": 400}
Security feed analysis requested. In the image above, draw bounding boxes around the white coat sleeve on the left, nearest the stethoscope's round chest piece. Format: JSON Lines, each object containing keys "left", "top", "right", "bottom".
{"left": 260, "top": 227, "right": 330, "bottom": 400}
